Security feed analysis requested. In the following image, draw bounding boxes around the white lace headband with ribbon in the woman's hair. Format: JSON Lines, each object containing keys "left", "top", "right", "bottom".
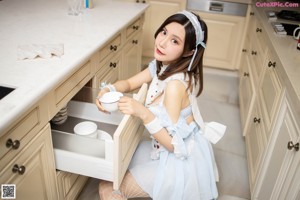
{"left": 178, "top": 10, "right": 206, "bottom": 71}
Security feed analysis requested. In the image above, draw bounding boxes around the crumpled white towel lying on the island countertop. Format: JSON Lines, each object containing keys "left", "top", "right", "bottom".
{"left": 17, "top": 44, "right": 64, "bottom": 60}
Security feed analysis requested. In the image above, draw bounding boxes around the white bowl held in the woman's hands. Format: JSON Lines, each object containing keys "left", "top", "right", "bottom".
{"left": 99, "top": 92, "right": 123, "bottom": 112}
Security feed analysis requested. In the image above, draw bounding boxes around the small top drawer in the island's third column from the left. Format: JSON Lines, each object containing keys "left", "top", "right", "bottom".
{"left": 100, "top": 34, "right": 122, "bottom": 62}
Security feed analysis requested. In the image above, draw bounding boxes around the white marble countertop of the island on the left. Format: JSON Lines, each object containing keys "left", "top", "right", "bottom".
{"left": 0, "top": 0, "right": 148, "bottom": 133}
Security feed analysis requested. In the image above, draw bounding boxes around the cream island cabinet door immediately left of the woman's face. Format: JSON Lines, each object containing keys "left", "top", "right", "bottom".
{"left": 121, "top": 32, "right": 142, "bottom": 79}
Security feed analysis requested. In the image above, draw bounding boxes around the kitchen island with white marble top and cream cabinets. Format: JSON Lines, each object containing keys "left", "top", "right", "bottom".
{"left": 0, "top": 0, "right": 148, "bottom": 199}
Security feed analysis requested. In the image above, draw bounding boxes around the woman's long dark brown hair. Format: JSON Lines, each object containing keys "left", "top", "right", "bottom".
{"left": 154, "top": 13, "right": 207, "bottom": 96}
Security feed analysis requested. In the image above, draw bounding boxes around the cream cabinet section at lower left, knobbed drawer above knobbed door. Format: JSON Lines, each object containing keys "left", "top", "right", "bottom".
{"left": 0, "top": 96, "right": 58, "bottom": 200}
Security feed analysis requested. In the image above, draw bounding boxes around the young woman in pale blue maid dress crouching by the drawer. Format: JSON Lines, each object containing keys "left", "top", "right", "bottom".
{"left": 96, "top": 10, "right": 225, "bottom": 200}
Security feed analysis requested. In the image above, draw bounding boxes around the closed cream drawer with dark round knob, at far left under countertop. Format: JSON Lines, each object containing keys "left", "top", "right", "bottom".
{"left": 0, "top": 97, "right": 48, "bottom": 169}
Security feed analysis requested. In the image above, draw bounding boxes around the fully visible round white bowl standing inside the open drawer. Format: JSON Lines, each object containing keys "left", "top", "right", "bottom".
{"left": 74, "top": 121, "right": 98, "bottom": 138}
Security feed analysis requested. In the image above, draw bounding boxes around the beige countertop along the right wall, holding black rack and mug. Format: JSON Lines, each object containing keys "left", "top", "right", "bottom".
{"left": 254, "top": 4, "right": 300, "bottom": 105}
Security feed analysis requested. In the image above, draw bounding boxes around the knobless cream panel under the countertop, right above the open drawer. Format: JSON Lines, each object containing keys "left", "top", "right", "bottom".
{"left": 49, "top": 61, "right": 92, "bottom": 118}
